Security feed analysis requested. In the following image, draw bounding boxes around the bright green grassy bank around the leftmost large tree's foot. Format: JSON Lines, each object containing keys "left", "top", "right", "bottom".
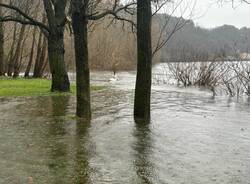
{"left": 0, "top": 77, "right": 104, "bottom": 97}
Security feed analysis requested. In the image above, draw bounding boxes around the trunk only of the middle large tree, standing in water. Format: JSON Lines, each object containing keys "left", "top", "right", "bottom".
{"left": 72, "top": 2, "right": 91, "bottom": 120}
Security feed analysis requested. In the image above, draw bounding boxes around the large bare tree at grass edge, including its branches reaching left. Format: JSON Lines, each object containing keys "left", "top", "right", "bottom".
{"left": 0, "top": 0, "right": 70, "bottom": 92}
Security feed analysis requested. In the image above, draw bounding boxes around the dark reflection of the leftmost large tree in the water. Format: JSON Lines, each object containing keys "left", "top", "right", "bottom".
{"left": 44, "top": 96, "right": 69, "bottom": 183}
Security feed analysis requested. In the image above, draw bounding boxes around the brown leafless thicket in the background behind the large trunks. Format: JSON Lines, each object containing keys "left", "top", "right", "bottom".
{"left": 2, "top": 12, "right": 137, "bottom": 78}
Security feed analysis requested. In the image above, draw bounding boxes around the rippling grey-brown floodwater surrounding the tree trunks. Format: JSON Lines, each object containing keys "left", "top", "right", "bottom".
{"left": 0, "top": 65, "right": 250, "bottom": 184}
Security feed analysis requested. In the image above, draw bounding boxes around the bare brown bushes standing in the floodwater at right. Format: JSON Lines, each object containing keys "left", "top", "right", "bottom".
{"left": 155, "top": 61, "right": 250, "bottom": 97}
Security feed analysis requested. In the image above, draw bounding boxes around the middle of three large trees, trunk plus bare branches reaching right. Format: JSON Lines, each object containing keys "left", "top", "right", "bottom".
{"left": 71, "top": 0, "right": 134, "bottom": 119}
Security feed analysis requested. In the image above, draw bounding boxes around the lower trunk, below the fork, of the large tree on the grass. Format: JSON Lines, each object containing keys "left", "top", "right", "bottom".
{"left": 48, "top": 31, "right": 70, "bottom": 92}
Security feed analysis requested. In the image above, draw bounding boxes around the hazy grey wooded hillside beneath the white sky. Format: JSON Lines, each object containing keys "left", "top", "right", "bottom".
{"left": 158, "top": 15, "right": 250, "bottom": 62}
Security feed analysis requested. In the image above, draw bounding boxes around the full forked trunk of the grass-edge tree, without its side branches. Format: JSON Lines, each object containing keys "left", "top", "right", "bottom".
{"left": 43, "top": 0, "right": 70, "bottom": 92}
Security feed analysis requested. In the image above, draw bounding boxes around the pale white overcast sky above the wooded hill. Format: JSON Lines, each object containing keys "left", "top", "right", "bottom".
{"left": 153, "top": 0, "right": 250, "bottom": 28}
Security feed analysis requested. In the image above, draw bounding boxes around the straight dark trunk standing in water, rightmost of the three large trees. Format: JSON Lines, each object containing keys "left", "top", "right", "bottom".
{"left": 134, "top": 0, "right": 152, "bottom": 122}
